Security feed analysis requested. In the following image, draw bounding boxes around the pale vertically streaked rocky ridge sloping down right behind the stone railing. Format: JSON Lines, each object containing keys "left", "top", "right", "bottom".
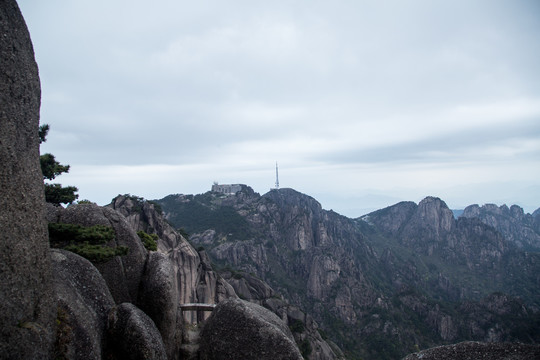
{"left": 109, "top": 195, "right": 342, "bottom": 360}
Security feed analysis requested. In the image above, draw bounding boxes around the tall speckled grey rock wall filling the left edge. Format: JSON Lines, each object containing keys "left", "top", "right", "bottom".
{"left": 0, "top": 0, "right": 56, "bottom": 359}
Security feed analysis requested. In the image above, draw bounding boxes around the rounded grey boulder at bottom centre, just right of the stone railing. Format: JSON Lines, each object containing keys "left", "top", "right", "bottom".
{"left": 200, "top": 299, "right": 302, "bottom": 360}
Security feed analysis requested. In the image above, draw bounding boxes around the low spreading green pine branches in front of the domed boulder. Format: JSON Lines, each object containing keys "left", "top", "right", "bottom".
{"left": 49, "top": 223, "right": 129, "bottom": 263}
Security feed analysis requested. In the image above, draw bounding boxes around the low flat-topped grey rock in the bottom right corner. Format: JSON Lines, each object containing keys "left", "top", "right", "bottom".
{"left": 403, "top": 341, "right": 540, "bottom": 360}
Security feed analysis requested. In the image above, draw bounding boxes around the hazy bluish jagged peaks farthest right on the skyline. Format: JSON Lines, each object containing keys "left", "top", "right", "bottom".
{"left": 462, "top": 204, "right": 540, "bottom": 250}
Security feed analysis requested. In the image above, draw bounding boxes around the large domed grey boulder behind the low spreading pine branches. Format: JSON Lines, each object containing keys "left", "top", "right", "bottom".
{"left": 52, "top": 204, "right": 148, "bottom": 304}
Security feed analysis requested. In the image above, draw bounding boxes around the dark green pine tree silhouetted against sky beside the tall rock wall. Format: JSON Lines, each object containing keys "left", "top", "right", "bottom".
{"left": 39, "top": 124, "right": 79, "bottom": 205}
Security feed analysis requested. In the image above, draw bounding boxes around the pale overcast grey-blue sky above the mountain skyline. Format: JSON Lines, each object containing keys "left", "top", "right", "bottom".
{"left": 18, "top": 0, "right": 540, "bottom": 217}
